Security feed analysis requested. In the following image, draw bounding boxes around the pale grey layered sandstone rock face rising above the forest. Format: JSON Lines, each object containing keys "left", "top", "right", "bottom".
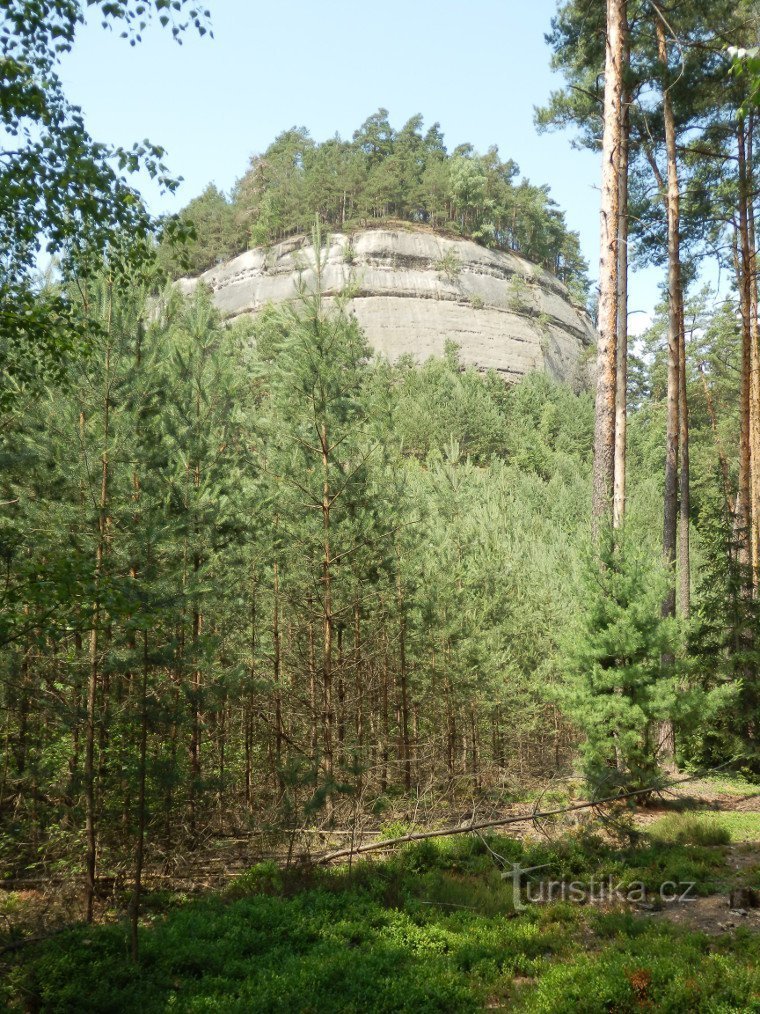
{"left": 178, "top": 229, "right": 596, "bottom": 382}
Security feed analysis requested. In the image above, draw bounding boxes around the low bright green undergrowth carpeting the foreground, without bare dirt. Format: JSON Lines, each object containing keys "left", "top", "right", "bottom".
{"left": 0, "top": 834, "right": 760, "bottom": 1014}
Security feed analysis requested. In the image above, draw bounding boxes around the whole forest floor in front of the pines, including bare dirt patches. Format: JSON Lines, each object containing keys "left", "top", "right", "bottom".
{"left": 0, "top": 779, "right": 760, "bottom": 1014}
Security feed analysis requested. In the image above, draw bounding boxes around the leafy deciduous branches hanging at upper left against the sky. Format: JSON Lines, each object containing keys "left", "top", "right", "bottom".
{"left": 0, "top": 0, "right": 209, "bottom": 405}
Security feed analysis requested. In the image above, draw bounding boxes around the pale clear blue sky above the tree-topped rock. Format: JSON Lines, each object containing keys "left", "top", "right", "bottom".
{"left": 63, "top": 0, "right": 660, "bottom": 330}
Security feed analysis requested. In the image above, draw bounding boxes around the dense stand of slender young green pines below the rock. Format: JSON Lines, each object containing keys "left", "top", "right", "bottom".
{"left": 0, "top": 259, "right": 608, "bottom": 855}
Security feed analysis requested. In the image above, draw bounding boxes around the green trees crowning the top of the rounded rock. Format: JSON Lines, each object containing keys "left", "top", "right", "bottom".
{"left": 162, "top": 110, "right": 588, "bottom": 303}
